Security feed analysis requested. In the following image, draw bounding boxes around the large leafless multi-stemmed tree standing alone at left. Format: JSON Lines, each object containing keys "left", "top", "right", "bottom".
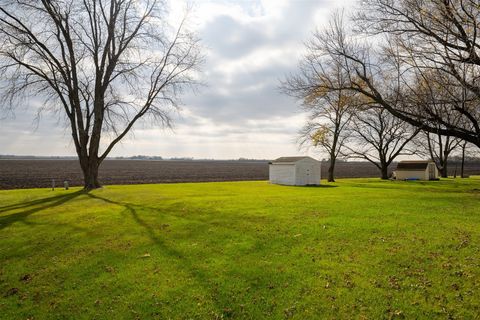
{"left": 0, "top": 0, "right": 202, "bottom": 189}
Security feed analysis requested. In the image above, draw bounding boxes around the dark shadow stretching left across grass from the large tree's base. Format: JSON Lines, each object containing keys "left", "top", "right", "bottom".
{"left": 0, "top": 190, "right": 85, "bottom": 230}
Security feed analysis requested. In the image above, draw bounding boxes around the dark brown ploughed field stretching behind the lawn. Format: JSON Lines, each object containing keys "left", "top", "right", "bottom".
{"left": 0, "top": 160, "right": 480, "bottom": 189}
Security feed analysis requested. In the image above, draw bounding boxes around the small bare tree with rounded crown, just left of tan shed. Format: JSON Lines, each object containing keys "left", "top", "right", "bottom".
{"left": 345, "top": 107, "right": 420, "bottom": 179}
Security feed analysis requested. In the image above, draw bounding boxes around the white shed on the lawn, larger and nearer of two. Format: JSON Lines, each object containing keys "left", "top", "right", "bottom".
{"left": 269, "top": 157, "right": 321, "bottom": 186}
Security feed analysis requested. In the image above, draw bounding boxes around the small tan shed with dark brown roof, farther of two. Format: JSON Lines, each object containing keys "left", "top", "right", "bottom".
{"left": 395, "top": 161, "right": 438, "bottom": 180}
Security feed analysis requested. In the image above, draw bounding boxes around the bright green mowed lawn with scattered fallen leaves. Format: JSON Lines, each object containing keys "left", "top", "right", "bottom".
{"left": 0, "top": 178, "right": 480, "bottom": 319}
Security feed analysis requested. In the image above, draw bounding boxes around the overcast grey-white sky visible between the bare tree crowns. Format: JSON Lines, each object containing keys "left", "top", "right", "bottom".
{"left": 0, "top": 0, "right": 354, "bottom": 159}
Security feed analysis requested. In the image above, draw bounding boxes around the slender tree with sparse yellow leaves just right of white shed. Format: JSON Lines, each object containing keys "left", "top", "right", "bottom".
{"left": 281, "top": 14, "right": 356, "bottom": 182}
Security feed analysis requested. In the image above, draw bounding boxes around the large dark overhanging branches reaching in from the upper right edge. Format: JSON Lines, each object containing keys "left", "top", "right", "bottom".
{"left": 292, "top": 0, "right": 480, "bottom": 147}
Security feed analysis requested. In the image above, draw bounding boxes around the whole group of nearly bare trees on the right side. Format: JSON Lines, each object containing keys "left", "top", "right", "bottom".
{"left": 281, "top": 0, "right": 480, "bottom": 181}
